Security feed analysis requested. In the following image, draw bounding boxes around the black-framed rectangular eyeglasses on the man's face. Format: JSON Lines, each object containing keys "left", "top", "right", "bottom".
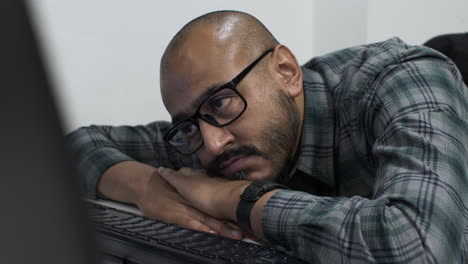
{"left": 164, "top": 49, "right": 273, "bottom": 155}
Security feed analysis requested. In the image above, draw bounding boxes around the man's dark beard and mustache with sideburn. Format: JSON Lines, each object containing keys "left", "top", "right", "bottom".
{"left": 207, "top": 84, "right": 301, "bottom": 180}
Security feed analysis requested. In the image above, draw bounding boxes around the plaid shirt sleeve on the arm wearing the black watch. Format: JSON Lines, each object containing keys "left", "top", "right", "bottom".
{"left": 262, "top": 58, "right": 468, "bottom": 263}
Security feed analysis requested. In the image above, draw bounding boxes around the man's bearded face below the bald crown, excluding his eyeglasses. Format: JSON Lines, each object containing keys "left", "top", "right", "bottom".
{"left": 162, "top": 38, "right": 301, "bottom": 180}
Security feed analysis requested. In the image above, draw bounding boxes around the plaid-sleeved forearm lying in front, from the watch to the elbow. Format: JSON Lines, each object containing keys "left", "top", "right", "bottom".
{"left": 262, "top": 191, "right": 463, "bottom": 263}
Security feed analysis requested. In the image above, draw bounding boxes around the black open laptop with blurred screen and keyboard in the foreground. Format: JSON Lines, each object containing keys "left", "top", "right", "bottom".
{"left": 0, "top": 0, "right": 299, "bottom": 264}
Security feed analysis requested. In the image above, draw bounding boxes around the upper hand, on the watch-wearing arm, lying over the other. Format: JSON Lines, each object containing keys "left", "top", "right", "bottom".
{"left": 158, "top": 167, "right": 250, "bottom": 221}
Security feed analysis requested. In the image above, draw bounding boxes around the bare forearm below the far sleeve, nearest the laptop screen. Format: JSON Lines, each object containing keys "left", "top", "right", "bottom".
{"left": 97, "top": 161, "right": 156, "bottom": 204}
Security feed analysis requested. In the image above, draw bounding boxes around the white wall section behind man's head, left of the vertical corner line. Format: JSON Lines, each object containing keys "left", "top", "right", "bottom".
{"left": 30, "top": 0, "right": 313, "bottom": 130}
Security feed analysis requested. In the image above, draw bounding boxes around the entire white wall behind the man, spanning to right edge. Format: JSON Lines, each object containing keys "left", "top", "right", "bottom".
{"left": 30, "top": 0, "right": 468, "bottom": 131}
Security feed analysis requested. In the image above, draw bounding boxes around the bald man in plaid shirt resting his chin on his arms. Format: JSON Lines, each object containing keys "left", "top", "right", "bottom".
{"left": 70, "top": 11, "right": 468, "bottom": 263}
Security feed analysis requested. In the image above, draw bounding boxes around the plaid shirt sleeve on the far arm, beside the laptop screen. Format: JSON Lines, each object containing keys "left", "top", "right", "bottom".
{"left": 67, "top": 121, "right": 201, "bottom": 198}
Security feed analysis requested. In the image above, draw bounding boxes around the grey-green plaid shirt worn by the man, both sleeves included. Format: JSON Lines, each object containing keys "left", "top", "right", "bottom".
{"left": 70, "top": 38, "right": 468, "bottom": 263}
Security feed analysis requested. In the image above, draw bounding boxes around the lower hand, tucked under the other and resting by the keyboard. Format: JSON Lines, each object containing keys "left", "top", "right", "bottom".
{"left": 136, "top": 170, "right": 243, "bottom": 239}
